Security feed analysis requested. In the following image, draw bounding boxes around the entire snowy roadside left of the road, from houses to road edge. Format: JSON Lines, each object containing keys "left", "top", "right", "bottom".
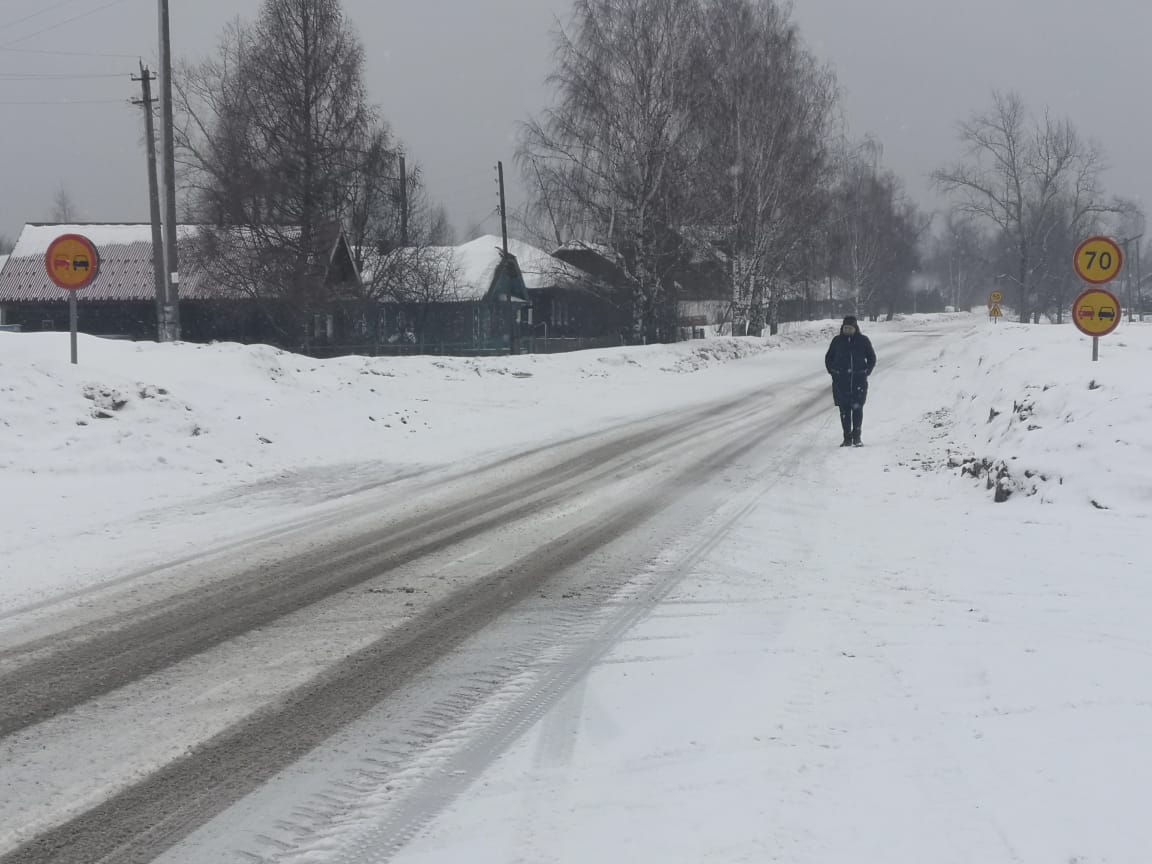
{"left": 0, "top": 333, "right": 790, "bottom": 607}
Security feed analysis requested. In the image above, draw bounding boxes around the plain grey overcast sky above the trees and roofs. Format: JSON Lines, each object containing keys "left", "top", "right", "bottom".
{"left": 0, "top": 0, "right": 1152, "bottom": 244}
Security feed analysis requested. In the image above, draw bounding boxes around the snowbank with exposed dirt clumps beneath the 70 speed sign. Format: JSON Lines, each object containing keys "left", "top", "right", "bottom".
{"left": 937, "top": 323, "right": 1152, "bottom": 513}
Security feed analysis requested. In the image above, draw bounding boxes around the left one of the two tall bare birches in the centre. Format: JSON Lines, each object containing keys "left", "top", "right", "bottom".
{"left": 520, "top": 0, "right": 703, "bottom": 339}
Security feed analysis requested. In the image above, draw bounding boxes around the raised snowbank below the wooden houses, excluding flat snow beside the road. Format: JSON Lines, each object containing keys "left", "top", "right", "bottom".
{"left": 0, "top": 333, "right": 766, "bottom": 480}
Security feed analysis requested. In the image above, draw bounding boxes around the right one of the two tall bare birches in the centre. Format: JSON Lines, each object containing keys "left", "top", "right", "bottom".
{"left": 700, "top": 0, "right": 836, "bottom": 333}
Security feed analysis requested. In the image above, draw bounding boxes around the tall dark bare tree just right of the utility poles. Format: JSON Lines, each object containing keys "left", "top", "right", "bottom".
{"left": 177, "top": 0, "right": 373, "bottom": 348}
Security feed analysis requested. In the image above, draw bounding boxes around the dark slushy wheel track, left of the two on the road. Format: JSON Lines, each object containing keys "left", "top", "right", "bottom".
{"left": 0, "top": 389, "right": 766, "bottom": 738}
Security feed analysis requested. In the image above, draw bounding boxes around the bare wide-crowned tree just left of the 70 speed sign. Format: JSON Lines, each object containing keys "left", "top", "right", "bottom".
{"left": 933, "top": 92, "right": 1113, "bottom": 321}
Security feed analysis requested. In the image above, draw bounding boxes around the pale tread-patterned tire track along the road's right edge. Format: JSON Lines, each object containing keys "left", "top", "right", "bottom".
{"left": 224, "top": 403, "right": 824, "bottom": 864}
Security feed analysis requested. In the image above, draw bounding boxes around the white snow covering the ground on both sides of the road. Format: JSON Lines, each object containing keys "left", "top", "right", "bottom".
{"left": 0, "top": 316, "right": 1152, "bottom": 864}
